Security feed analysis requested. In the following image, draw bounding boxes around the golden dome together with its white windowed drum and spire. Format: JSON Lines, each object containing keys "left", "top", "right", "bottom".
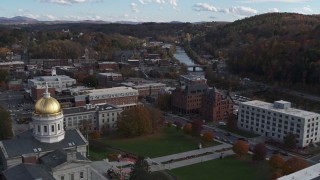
{"left": 32, "top": 85, "right": 65, "bottom": 143}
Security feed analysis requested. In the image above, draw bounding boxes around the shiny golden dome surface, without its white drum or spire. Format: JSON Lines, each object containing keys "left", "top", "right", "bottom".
{"left": 34, "top": 96, "right": 61, "bottom": 115}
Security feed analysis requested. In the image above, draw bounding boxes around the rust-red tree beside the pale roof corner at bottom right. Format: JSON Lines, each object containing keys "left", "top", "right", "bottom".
{"left": 282, "top": 157, "right": 308, "bottom": 175}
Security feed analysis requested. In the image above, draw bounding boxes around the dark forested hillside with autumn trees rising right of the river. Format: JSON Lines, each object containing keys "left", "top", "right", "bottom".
{"left": 192, "top": 13, "right": 320, "bottom": 85}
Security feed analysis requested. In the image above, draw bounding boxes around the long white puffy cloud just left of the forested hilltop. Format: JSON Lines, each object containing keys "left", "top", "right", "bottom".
{"left": 193, "top": 3, "right": 258, "bottom": 16}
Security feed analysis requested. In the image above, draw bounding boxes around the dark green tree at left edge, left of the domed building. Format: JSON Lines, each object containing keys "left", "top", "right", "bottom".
{"left": 0, "top": 107, "right": 13, "bottom": 140}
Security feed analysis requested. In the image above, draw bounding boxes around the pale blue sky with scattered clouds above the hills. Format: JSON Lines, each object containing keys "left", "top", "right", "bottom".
{"left": 0, "top": 0, "right": 320, "bottom": 22}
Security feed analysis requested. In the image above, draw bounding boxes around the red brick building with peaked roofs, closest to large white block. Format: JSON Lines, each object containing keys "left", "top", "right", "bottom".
{"left": 201, "top": 88, "right": 233, "bottom": 121}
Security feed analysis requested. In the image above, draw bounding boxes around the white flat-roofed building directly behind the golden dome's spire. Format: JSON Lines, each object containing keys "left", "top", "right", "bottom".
{"left": 28, "top": 75, "right": 77, "bottom": 92}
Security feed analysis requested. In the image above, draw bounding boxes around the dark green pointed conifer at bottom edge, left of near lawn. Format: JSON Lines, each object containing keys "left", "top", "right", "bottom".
{"left": 129, "top": 156, "right": 151, "bottom": 180}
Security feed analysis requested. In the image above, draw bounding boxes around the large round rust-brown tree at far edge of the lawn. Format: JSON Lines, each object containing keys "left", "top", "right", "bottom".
{"left": 117, "top": 107, "right": 152, "bottom": 137}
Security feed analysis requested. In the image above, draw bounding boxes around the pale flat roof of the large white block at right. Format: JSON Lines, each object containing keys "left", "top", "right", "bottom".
{"left": 240, "top": 100, "right": 320, "bottom": 118}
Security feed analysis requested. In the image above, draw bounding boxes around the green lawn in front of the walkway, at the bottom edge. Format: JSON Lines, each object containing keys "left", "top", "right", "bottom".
{"left": 170, "top": 156, "right": 272, "bottom": 180}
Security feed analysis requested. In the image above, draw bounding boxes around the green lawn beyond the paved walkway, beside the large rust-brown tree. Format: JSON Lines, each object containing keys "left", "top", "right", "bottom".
{"left": 91, "top": 127, "right": 220, "bottom": 158}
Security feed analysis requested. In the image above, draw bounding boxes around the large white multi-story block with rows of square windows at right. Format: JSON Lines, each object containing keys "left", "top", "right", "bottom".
{"left": 237, "top": 100, "right": 320, "bottom": 147}
